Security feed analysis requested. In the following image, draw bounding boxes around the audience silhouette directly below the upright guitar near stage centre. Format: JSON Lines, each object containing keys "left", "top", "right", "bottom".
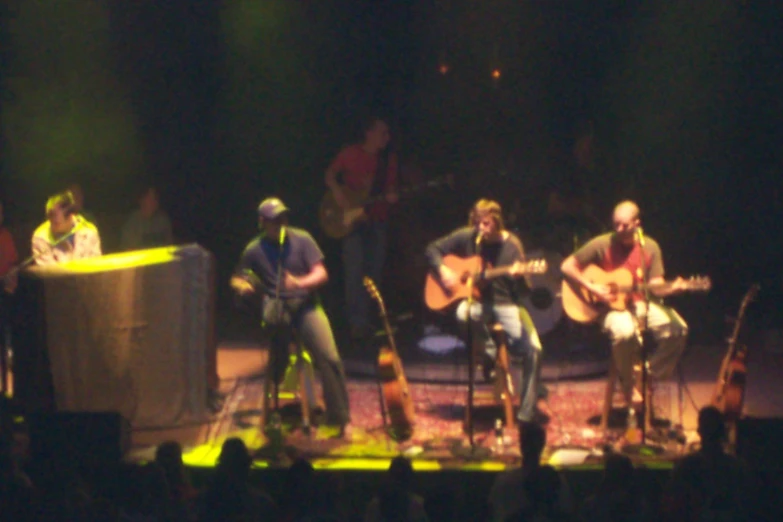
{"left": 364, "top": 456, "right": 429, "bottom": 522}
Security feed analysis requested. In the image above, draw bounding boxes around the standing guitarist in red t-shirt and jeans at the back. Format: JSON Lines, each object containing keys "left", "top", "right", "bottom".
{"left": 326, "top": 118, "right": 398, "bottom": 339}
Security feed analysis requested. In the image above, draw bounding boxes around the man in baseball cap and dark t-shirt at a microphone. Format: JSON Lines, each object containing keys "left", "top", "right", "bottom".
{"left": 231, "top": 197, "right": 351, "bottom": 437}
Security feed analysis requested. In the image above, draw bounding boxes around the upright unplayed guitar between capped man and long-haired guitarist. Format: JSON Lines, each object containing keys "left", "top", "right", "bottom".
{"left": 364, "top": 277, "right": 415, "bottom": 442}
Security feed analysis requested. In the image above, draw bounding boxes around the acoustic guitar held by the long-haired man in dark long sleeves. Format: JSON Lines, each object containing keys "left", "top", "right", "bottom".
{"left": 424, "top": 254, "right": 547, "bottom": 311}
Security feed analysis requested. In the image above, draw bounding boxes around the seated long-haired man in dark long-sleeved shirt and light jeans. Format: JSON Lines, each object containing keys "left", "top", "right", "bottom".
{"left": 426, "top": 199, "right": 548, "bottom": 422}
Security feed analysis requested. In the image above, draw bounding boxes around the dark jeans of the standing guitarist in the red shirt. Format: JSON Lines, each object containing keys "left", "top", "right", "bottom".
{"left": 343, "top": 222, "right": 388, "bottom": 330}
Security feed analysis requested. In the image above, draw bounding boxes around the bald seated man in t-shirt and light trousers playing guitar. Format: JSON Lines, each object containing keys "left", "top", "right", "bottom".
{"left": 561, "top": 201, "right": 688, "bottom": 406}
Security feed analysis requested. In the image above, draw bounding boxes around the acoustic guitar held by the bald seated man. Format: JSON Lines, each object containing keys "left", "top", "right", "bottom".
{"left": 561, "top": 265, "right": 712, "bottom": 323}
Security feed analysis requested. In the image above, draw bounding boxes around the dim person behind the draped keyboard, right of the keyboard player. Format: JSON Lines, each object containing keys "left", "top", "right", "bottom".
{"left": 120, "top": 187, "right": 174, "bottom": 250}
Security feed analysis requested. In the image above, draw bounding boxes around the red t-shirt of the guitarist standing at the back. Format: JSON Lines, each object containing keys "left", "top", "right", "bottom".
{"left": 329, "top": 143, "right": 397, "bottom": 221}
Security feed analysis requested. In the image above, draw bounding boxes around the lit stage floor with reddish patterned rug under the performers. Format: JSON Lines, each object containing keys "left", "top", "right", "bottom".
{"left": 125, "top": 332, "right": 783, "bottom": 471}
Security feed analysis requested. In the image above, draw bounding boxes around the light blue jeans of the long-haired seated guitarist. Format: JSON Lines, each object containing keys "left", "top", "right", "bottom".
{"left": 457, "top": 301, "right": 541, "bottom": 422}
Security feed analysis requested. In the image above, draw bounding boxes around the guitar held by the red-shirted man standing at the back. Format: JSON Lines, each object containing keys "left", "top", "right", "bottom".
{"left": 318, "top": 174, "right": 454, "bottom": 239}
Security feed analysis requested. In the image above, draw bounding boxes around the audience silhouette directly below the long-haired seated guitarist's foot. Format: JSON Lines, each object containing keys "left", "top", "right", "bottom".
{"left": 488, "top": 422, "right": 573, "bottom": 522}
